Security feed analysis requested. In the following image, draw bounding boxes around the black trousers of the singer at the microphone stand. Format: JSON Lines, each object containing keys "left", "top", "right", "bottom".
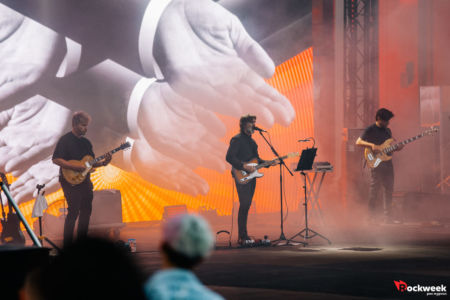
{"left": 235, "top": 178, "right": 256, "bottom": 239}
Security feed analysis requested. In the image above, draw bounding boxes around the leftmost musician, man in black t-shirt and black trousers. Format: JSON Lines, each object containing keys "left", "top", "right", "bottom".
{"left": 52, "top": 111, "right": 111, "bottom": 246}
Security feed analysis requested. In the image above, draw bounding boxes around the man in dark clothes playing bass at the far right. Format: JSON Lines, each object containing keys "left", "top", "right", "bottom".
{"left": 356, "top": 108, "right": 403, "bottom": 223}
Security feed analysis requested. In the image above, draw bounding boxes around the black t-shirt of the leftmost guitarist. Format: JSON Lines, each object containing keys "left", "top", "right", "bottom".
{"left": 52, "top": 131, "right": 95, "bottom": 182}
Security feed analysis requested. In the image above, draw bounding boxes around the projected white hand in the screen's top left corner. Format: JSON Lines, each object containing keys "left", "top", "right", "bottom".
{"left": 0, "top": 4, "right": 65, "bottom": 109}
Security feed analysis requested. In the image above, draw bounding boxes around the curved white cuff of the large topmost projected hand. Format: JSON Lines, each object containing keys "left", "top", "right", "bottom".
{"left": 139, "top": 0, "right": 171, "bottom": 79}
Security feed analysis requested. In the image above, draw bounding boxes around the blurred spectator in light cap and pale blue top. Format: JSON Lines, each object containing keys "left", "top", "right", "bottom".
{"left": 144, "top": 214, "right": 224, "bottom": 300}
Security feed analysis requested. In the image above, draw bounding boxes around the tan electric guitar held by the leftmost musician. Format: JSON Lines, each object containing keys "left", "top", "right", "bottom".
{"left": 62, "top": 142, "right": 131, "bottom": 185}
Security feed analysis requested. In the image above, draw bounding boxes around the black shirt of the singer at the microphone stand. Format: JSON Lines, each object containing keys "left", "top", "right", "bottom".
{"left": 226, "top": 133, "right": 262, "bottom": 170}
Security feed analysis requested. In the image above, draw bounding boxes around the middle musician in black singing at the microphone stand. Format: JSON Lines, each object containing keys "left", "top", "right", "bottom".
{"left": 226, "top": 115, "right": 277, "bottom": 245}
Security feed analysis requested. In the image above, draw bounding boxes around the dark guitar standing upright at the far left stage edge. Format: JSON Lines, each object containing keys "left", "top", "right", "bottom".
{"left": 0, "top": 172, "right": 25, "bottom": 245}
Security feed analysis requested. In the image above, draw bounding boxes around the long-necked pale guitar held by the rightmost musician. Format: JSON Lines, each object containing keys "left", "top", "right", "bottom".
{"left": 364, "top": 127, "right": 439, "bottom": 169}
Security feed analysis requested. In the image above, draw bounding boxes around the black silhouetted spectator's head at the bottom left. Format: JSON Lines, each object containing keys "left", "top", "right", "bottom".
{"left": 21, "top": 237, "right": 146, "bottom": 300}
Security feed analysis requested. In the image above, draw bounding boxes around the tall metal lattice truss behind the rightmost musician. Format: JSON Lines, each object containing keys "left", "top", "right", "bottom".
{"left": 344, "top": 0, "right": 379, "bottom": 128}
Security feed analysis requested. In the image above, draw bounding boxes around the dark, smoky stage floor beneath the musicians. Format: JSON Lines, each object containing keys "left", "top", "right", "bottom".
{"left": 34, "top": 213, "right": 450, "bottom": 299}
